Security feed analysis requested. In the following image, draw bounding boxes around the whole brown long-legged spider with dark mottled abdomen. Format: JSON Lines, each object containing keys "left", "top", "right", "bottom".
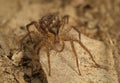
{"left": 21, "top": 14, "right": 99, "bottom": 76}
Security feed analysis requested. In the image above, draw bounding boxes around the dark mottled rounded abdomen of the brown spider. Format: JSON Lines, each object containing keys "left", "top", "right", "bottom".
{"left": 39, "top": 14, "right": 61, "bottom": 35}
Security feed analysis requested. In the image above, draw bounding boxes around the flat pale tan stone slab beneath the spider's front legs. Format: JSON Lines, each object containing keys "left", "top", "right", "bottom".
{"left": 41, "top": 35, "right": 118, "bottom": 83}
